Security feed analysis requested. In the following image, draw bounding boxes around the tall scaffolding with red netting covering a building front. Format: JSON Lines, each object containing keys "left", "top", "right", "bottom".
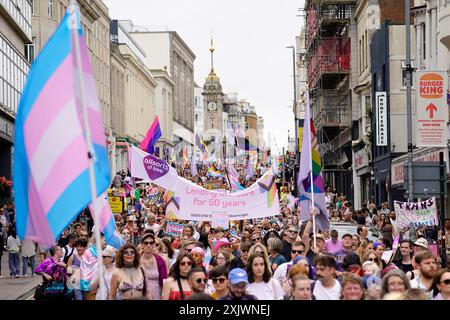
{"left": 305, "top": 0, "right": 355, "bottom": 196}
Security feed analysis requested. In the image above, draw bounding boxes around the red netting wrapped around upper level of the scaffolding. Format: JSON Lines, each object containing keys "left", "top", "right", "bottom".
{"left": 308, "top": 38, "right": 350, "bottom": 88}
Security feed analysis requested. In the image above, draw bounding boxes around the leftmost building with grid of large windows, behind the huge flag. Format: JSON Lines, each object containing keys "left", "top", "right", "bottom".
{"left": 0, "top": 0, "right": 33, "bottom": 181}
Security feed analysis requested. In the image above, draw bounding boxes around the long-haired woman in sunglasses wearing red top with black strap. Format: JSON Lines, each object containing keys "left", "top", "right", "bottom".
{"left": 161, "top": 252, "right": 195, "bottom": 300}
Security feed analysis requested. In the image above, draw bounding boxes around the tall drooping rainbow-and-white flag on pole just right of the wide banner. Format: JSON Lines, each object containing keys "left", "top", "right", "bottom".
{"left": 297, "top": 93, "right": 330, "bottom": 232}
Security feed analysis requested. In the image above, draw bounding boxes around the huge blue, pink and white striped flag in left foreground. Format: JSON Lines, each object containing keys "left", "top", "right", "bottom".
{"left": 13, "top": 5, "right": 110, "bottom": 247}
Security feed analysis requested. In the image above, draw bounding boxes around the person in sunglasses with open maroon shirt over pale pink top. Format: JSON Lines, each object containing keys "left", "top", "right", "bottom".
{"left": 141, "top": 232, "right": 167, "bottom": 300}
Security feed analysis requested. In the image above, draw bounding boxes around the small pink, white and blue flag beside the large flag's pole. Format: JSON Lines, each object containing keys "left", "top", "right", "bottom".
{"left": 89, "top": 193, "right": 125, "bottom": 249}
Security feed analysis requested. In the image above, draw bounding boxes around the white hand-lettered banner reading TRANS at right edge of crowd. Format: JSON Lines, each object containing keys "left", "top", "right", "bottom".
{"left": 394, "top": 197, "right": 438, "bottom": 228}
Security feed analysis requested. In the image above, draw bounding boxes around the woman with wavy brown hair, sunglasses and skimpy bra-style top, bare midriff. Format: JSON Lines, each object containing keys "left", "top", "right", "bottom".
{"left": 109, "top": 243, "right": 147, "bottom": 300}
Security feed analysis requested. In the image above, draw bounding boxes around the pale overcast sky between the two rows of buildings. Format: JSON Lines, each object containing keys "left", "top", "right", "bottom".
{"left": 103, "top": 0, "right": 303, "bottom": 155}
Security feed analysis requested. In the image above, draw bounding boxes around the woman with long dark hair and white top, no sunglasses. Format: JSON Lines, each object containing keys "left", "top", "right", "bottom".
{"left": 247, "top": 253, "right": 284, "bottom": 300}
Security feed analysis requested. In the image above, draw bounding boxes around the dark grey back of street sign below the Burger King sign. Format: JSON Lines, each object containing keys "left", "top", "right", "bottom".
{"left": 403, "top": 162, "right": 447, "bottom": 198}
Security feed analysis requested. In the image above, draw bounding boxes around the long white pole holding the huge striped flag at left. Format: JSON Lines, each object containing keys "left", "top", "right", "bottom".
{"left": 69, "top": 0, "right": 106, "bottom": 300}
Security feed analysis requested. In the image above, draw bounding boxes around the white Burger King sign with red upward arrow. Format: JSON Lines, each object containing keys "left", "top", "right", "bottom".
{"left": 416, "top": 71, "right": 448, "bottom": 147}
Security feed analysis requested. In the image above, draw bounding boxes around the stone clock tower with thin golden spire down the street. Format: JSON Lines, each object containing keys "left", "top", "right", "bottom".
{"left": 202, "top": 37, "right": 225, "bottom": 146}
